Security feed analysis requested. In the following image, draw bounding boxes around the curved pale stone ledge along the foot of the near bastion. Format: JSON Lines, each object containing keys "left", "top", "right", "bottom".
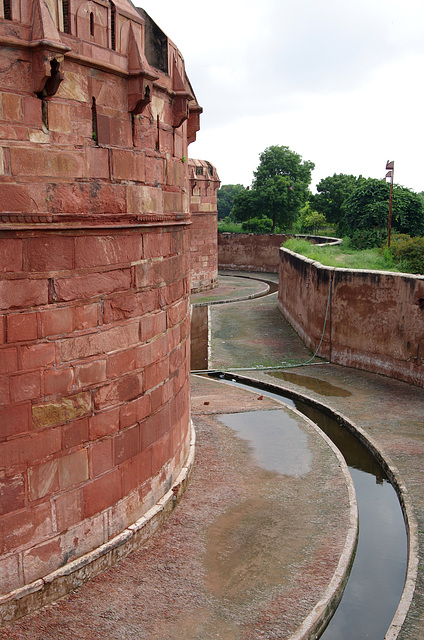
{"left": 0, "top": 422, "right": 196, "bottom": 626}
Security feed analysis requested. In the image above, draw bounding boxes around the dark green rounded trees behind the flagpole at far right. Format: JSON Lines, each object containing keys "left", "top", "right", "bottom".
{"left": 341, "top": 178, "right": 424, "bottom": 236}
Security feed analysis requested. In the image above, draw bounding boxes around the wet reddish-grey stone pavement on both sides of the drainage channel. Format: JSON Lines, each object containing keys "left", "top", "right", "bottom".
{"left": 0, "top": 274, "right": 424, "bottom": 640}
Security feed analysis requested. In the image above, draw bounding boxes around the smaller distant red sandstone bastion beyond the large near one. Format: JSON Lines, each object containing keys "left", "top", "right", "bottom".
{"left": 188, "top": 159, "right": 220, "bottom": 293}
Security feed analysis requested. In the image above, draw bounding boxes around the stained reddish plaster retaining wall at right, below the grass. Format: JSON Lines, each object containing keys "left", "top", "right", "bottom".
{"left": 278, "top": 249, "right": 424, "bottom": 386}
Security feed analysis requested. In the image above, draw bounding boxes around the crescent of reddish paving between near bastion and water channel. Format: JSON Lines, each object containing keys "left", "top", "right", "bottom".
{"left": 0, "top": 377, "right": 357, "bottom": 640}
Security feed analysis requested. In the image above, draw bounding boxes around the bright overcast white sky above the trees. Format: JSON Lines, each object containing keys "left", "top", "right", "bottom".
{"left": 139, "top": 0, "right": 424, "bottom": 191}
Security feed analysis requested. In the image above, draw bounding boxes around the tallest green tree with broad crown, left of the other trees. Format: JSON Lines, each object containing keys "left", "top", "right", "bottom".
{"left": 233, "top": 146, "right": 315, "bottom": 233}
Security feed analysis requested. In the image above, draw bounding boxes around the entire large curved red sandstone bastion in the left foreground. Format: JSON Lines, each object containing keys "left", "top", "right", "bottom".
{"left": 0, "top": 0, "right": 201, "bottom": 620}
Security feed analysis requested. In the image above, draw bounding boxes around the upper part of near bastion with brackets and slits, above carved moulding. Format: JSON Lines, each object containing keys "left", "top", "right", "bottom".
{"left": 0, "top": 0, "right": 202, "bottom": 228}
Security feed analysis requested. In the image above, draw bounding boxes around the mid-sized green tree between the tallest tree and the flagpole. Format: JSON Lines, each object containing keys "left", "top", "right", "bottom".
{"left": 310, "top": 173, "right": 363, "bottom": 224}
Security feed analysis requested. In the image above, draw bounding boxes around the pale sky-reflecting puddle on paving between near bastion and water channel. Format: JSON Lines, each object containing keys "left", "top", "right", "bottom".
{"left": 215, "top": 411, "right": 312, "bottom": 478}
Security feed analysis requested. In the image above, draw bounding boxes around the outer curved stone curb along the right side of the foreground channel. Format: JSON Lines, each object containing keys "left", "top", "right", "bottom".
{"left": 220, "top": 373, "right": 419, "bottom": 640}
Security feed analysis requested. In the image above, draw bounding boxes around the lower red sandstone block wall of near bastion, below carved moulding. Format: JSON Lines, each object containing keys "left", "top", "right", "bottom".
{"left": 0, "top": 229, "right": 189, "bottom": 591}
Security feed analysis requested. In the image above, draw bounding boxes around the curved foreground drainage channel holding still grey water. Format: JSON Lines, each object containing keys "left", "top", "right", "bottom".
{"left": 209, "top": 374, "right": 407, "bottom": 640}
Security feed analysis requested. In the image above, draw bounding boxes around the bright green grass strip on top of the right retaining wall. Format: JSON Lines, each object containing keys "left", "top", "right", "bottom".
{"left": 283, "top": 238, "right": 402, "bottom": 272}
